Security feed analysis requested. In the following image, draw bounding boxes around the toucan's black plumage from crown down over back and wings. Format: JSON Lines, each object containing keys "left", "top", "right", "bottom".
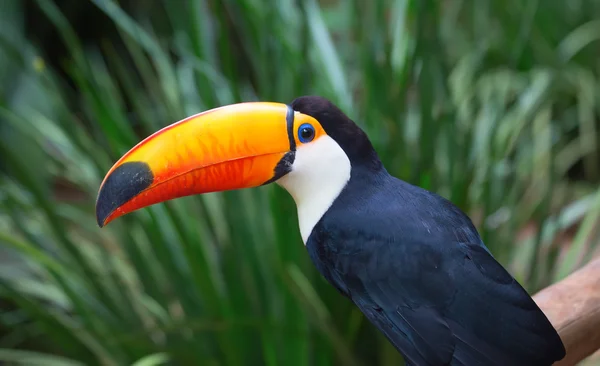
{"left": 292, "top": 97, "right": 565, "bottom": 366}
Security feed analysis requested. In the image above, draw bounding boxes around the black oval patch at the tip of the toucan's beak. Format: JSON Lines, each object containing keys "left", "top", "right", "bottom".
{"left": 96, "top": 161, "right": 154, "bottom": 227}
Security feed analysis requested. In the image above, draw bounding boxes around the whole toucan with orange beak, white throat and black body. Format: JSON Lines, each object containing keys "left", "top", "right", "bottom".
{"left": 96, "top": 96, "right": 565, "bottom": 366}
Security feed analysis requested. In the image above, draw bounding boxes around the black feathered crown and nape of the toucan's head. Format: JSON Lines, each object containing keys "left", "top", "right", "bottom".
{"left": 290, "top": 96, "right": 381, "bottom": 169}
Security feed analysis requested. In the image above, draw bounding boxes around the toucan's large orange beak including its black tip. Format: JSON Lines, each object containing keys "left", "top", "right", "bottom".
{"left": 96, "top": 102, "right": 298, "bottom": 227}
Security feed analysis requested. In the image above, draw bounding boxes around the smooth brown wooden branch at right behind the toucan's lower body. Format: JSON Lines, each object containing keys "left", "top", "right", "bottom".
{"left": 533, "top": 258, "right": 600, "bottom": 366}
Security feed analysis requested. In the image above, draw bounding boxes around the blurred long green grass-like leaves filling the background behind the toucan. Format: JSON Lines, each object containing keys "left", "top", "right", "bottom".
{"left": 0, "top": 0, "right": 600, "bottom": 366}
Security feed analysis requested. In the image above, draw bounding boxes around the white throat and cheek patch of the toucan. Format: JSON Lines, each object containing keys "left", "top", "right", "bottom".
{"left": 277, "top": 135, "right": 351, "bottom": 245}
